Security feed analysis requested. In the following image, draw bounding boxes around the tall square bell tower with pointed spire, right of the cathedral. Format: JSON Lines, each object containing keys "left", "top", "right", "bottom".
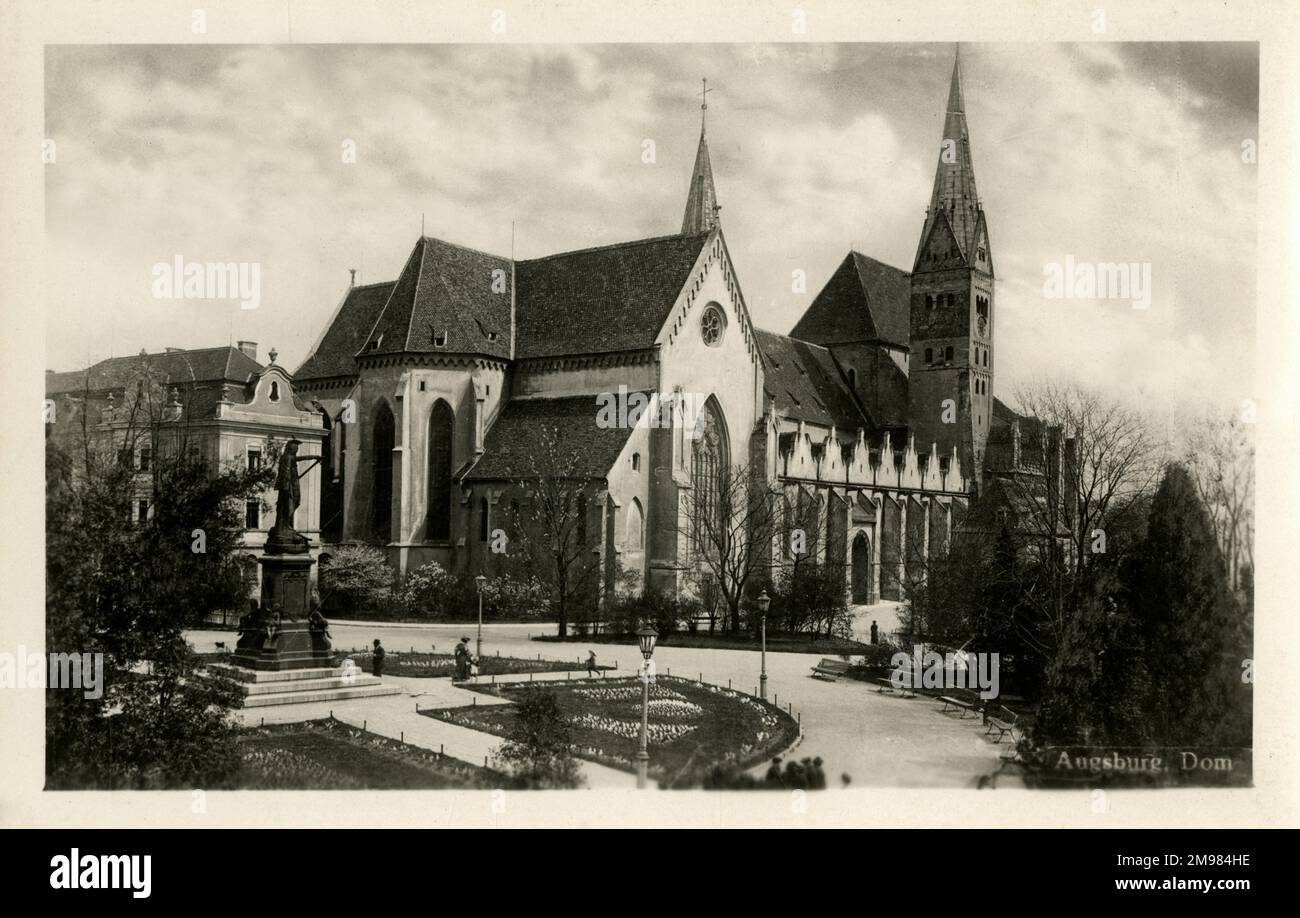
{"left": 907, "top": 49, "right": 995, "bottom": 480}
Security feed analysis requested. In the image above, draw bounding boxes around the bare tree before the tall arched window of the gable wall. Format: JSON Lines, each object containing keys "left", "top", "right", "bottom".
{"left": 677, "top": 466, "right": 780, "bottom": 632}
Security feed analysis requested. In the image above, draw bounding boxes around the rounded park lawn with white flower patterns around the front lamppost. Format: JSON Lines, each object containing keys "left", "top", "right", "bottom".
{"left": 420, "top": 676, "right": 800, "bottom": 787}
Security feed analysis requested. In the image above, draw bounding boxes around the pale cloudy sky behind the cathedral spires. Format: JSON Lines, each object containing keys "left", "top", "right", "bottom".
{"left": 46, "top": 44, "right": 1258, "bottom": 407}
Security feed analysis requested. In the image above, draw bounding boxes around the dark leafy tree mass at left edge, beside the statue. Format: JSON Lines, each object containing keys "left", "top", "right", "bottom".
{"left": 46, "top": 367, "right": 274, "bottom": 789}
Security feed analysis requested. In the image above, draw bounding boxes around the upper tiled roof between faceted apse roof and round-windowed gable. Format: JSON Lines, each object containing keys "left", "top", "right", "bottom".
{"left": 516, "top": 233, "right": 710, "bottom": 359}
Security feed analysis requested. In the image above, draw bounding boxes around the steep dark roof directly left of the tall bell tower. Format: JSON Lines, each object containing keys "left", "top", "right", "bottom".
{"left": 790, "top": 252, "right": 911, "bottom": 347}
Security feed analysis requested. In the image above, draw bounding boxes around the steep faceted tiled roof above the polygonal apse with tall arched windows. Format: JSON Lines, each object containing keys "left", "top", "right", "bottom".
{"left": 356, "top": 237, "right": 510, "bottom": 358}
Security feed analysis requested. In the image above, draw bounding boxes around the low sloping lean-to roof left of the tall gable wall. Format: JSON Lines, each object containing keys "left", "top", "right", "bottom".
{"left": 465, "top": 395, "right": 642, "bottom": 481}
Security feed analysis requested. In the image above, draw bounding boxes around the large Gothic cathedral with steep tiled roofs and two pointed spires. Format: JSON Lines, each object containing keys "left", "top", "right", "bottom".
{"left": 293, "top": 50, "right": 1014, "bottom": 603}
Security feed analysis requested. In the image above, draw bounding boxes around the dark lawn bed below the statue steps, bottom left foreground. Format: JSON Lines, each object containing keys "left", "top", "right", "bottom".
{"left": 231, "top": 718, "right": 499, "bottom": 791}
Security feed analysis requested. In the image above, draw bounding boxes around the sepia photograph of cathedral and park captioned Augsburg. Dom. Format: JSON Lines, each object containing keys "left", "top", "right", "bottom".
{"left": 32, "top": 40, "right": 1260, "bottom": 807}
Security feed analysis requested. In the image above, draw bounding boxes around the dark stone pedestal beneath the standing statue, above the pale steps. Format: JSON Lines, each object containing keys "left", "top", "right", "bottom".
{"left": 230, "top": 554, "right": 334, "bottom": 671}
